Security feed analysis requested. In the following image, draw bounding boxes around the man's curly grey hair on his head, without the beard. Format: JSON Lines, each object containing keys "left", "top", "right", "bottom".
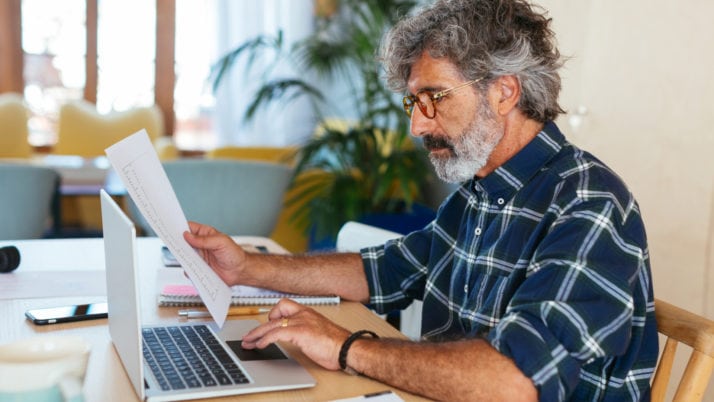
{"left": 380, "top": 0, "right": 564, "bottom": 122}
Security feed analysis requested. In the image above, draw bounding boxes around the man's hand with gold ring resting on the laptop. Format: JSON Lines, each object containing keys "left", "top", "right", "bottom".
{"left": 243, "top": 299, "right": 350, "bottom": 370}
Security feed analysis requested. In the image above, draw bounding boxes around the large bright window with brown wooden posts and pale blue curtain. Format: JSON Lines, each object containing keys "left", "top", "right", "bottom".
{"left": 0, "top": 0, "right": 312, "bottom": 150}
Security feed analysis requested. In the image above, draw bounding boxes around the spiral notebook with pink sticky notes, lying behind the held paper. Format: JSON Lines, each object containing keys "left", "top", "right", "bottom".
{"left": 158, "top": 284, "right": 340, "bottom": 307}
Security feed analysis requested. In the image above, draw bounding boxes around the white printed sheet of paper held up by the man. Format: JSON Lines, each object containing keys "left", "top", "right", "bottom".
{"left": 106, "top": 130, "right": 231, "bottom": 327}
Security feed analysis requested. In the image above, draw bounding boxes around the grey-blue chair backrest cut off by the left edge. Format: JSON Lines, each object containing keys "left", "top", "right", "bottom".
{"left": 0, "top": 164, "right": 59, "bottom": 240}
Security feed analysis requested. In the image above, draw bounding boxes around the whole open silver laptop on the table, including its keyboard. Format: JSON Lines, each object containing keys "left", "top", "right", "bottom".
{"left": 100, "top": 190, "right": 316, "bottom": 401}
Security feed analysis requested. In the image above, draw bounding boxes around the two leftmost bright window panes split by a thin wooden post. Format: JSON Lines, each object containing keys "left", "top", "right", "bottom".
{"left": 21, "top": 0, "right": 163, "bottom": 147}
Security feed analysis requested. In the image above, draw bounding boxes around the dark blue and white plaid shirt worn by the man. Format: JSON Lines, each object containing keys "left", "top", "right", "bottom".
{"left": 362, "top": 123, "right": 658, "bottom": 401}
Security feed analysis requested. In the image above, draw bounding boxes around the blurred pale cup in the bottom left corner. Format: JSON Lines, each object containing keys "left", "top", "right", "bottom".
{"left": 0, "top": 335, "right": 91, "bottom": 402}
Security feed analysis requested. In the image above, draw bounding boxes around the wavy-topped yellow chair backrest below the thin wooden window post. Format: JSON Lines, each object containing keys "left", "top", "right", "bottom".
{"left": 52, "top": 100, "right": 164, "bottom": 158}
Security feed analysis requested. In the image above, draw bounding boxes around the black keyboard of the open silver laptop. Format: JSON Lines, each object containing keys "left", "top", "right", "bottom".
{"left": 142, "top": 325, "right": 249, "bottom": 390}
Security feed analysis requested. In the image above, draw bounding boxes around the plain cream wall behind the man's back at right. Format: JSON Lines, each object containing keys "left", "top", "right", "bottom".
{"left": 538, "top": 0, "right": 714, "bottom": 400}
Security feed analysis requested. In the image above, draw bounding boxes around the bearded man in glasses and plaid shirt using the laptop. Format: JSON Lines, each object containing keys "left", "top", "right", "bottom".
{"left": 185, "top": 0, "right": 658, "bottom": 401}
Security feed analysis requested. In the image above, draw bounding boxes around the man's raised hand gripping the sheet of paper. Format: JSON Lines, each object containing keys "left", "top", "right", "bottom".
{"left": 183, "top": 222, "right": 246, "bottom": 285}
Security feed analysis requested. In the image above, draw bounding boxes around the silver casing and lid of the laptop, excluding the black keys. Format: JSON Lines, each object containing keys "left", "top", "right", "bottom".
{"left": 100, "top": 190, "right": 316, "bottom": 401}
